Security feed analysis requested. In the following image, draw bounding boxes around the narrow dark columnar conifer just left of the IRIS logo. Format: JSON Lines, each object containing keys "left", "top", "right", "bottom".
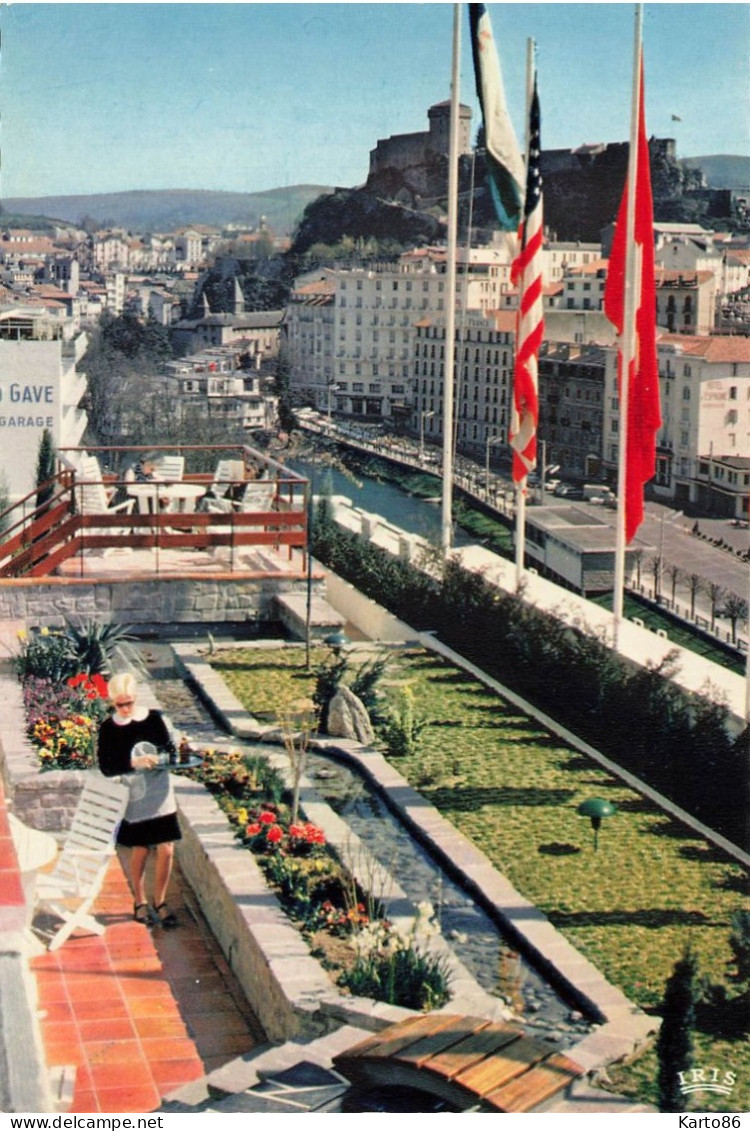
{"left": 656, "top": 949, "right": 698, "bottom": 1112}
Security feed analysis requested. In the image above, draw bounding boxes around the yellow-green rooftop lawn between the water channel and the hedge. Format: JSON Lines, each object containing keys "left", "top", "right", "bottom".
{"left": 213, "top": 647, "right": 750, "bottom": 1111}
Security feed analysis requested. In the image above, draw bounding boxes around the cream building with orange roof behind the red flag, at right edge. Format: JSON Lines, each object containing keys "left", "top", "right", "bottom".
{"left": 603, "top": 334, "right": 750, "bottom": 517}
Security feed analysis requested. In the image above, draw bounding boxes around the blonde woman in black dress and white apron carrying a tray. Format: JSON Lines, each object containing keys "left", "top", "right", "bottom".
{"left": 97, "top": 672, "right": 182, "bottom": 927}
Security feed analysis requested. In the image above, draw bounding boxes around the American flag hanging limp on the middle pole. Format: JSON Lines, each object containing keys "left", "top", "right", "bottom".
{"left": 509, "top": 80, "right": 544, "bottom": 483}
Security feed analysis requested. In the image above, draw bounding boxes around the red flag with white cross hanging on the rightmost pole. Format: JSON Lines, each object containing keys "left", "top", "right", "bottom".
{"left": 604, "top": 55, "right": 662, "bottom": 543}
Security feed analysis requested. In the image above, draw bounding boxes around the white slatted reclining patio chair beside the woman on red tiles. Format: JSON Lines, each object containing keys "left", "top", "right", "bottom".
{"left": 36, "top": 770, "right": 130, "bottom": 950}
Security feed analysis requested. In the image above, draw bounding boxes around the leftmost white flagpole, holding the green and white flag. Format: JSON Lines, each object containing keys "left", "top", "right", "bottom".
{"left": 441, "top": 3, "right": 460, "bottom": 553}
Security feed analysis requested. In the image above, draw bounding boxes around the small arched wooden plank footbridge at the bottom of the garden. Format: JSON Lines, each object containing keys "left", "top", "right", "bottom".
{"left": 334, "top": 1013, "right": 584, "bottom": 1113}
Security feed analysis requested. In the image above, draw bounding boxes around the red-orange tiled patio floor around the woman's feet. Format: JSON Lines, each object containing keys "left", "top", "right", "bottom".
{"left": 31, "top": 860, "right": 262, "bottom": 1113}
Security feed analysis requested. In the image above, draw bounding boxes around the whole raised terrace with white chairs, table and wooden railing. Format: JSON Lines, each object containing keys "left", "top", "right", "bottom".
{"left": 0, "top": 444, "right": 309, "bottom": 585}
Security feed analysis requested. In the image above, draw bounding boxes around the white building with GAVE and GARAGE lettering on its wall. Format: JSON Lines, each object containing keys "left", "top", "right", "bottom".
{"left": 0, "top": 305, "right": 87, "bottom": 500}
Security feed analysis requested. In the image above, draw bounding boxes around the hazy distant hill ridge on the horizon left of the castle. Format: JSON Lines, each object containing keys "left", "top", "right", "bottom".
{"left": 2, "top": 184, "right": 333, "bottom": 235}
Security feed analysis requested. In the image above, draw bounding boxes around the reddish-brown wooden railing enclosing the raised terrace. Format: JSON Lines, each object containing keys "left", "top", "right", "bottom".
{"left": 0, "top": 446, "right": 309, "bottom": 580}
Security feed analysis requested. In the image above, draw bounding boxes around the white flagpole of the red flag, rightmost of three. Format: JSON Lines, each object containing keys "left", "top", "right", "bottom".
{"left": 613, "top": 3, "right": 644, "bottom": 647}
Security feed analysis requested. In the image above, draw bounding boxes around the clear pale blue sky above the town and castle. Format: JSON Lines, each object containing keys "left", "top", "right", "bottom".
{"left": 0, "top": 2, "right": 750, "bottom": 198}
